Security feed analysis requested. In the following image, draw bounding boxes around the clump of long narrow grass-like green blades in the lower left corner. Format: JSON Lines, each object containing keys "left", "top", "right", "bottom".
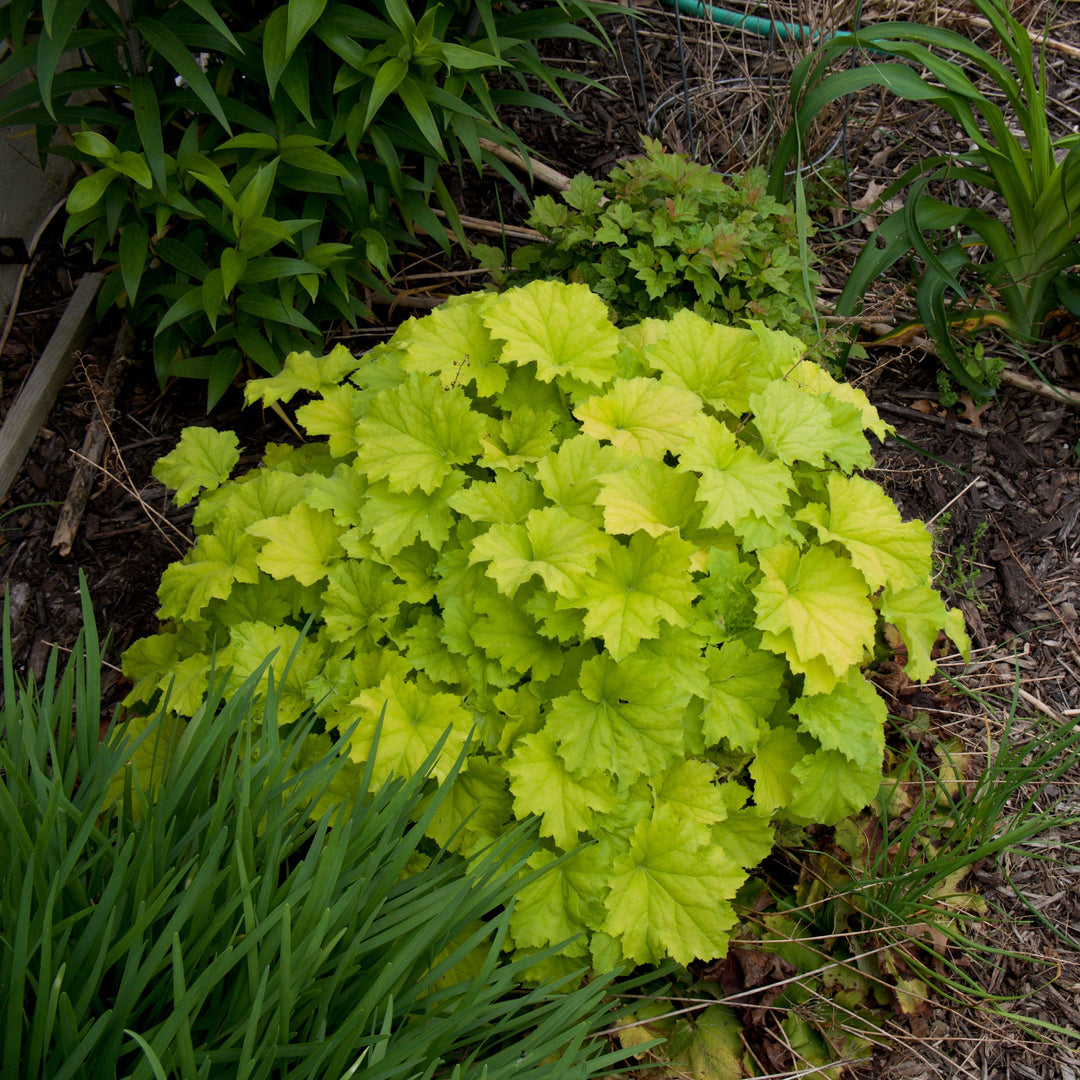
{"left": 0, "top": 587, "right": 623, "bottom": 1080}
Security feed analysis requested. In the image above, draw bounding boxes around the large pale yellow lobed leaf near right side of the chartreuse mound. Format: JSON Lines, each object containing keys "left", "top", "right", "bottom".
{"left": 754, "top": 544, "right": 877, "bottom": 676}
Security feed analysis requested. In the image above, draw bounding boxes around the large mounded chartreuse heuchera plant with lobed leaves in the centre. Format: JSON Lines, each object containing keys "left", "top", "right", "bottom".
{"left": 124, "top": 281, "right": 964, "bottom": 970}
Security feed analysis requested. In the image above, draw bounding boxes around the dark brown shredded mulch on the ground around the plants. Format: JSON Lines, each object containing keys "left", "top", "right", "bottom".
{"left": 0, "top": 0, "right": 1080, "bottom": 1080}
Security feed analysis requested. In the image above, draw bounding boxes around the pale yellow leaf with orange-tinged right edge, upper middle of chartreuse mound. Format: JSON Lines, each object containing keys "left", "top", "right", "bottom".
{"left": 573, "top": 378, "right": 701, "bottom": 461}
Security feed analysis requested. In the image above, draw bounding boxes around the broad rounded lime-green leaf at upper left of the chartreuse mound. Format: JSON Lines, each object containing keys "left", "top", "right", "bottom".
{"left": 356, "top": 375, "right": 487, "bottom": 495}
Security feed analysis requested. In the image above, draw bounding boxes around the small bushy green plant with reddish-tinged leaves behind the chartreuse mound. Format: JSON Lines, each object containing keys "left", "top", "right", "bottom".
{"left": 487, "top": 138, "right": 818, "bottom": 340}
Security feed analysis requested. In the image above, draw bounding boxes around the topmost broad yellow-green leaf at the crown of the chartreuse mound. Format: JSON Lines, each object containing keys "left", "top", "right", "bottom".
{"left": 483, "top": 281, "right": 619, "bottom": 386}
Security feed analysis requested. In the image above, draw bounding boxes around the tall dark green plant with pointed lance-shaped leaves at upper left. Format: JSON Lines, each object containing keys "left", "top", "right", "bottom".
{"left": 0, "top": 0, "right": 618, "bottom": 403}
